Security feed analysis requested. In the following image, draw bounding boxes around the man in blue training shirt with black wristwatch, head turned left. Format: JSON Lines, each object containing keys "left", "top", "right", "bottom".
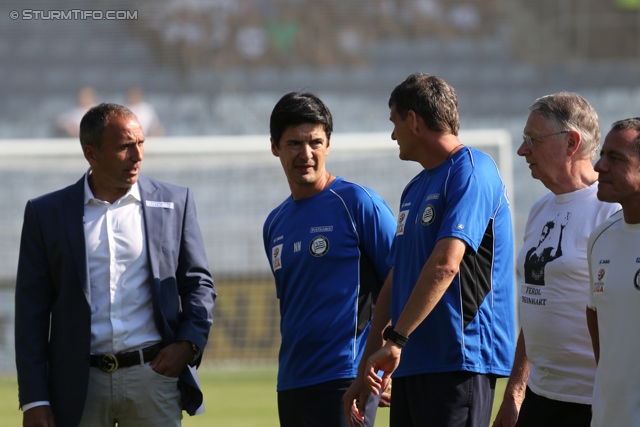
{"left": 344, "top": 74, "right": 515, "bottom": 427}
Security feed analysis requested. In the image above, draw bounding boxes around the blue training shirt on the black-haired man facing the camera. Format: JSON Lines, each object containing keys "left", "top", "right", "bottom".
{"left": 263, "top": 177, "right": 396, "bottom": 391}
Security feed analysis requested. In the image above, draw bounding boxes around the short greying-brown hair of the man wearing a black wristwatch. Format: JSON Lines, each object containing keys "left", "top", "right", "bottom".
{"left": 389, "top": 73, "right": 460, "bottom": 136}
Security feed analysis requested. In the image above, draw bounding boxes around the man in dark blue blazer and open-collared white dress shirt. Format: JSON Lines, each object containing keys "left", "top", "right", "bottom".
{"left": 15, "top": 104, "right": 216, "bottom": 427}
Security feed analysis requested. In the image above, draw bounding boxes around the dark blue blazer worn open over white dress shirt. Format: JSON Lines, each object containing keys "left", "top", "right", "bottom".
{"left": 15, "top": 176, "right": 216, "bottom": 427}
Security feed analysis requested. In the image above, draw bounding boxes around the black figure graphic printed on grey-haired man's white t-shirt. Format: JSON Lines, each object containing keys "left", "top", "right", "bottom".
{"left": 524, "top": 212, "right": 571, "bottom": 286}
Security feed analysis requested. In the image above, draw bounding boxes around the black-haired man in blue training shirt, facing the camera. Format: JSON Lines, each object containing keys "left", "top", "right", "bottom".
{"left": 263, "top": 92, "right": 396, "bottom": 427}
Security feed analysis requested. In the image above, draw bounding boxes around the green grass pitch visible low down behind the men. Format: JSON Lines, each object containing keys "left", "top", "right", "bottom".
{"left": 0, "top": 368, "right": 506, "bottom": 427}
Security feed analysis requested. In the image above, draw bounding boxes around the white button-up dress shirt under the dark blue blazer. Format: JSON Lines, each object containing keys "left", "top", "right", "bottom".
{"left": 84, "top": 172, "right": 162, "bottom": 354}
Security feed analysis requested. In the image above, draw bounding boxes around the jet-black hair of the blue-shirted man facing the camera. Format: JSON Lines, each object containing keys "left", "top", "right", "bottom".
{"left": 269, "top": 92, "right": 333, "bottom": 147}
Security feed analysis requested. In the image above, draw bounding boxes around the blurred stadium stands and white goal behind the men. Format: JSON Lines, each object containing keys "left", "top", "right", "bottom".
{"left": 0, "top": 0, "right": 640, "bottom": 371}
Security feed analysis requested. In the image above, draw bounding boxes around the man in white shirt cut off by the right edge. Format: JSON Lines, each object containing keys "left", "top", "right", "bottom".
{"left": 587, "top": 117, "right": 640, "bottom": 427}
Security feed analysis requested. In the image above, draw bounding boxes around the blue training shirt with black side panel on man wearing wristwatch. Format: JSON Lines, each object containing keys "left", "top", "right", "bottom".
{"left": 389, "top": 147, "right": 515, "bottom": 377}
